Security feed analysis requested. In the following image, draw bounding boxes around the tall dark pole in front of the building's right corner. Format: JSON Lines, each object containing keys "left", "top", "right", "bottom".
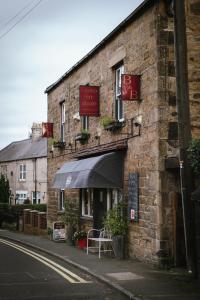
{"left": 174, "top": 0, "right": 197, "bottom": 277}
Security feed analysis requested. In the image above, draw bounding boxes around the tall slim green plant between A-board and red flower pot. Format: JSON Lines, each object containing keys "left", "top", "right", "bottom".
{"left": 62, "top": 199, "right": 78, "bottom": 246}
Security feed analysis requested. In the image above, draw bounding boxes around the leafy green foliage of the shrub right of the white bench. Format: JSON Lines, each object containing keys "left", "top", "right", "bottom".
{"left": 104, "top": 202, "right": 128, "bottom": 235}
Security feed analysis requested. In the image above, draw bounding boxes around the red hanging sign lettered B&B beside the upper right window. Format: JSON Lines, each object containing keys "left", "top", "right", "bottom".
{"left": 121, "top": 74, "right": 141, "bottom": 100}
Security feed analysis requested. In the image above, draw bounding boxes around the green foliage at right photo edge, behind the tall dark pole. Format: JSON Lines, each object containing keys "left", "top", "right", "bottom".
{"left": 187, "top": 139, "right": 200, "bottom": 175}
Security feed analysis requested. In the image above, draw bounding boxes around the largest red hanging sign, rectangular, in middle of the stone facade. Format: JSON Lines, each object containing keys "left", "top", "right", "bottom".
{"left": 79, "top": 85, "right": 99, "bottom": 117}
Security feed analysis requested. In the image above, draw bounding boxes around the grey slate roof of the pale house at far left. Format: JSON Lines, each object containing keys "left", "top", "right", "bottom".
{"left": 0, "top": 138, "right": 47, "bottom": 162}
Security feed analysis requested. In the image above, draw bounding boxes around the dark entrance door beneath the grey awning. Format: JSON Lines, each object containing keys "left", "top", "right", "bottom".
{"left": 93, "top": 189, "right": 107, "bottom": 229}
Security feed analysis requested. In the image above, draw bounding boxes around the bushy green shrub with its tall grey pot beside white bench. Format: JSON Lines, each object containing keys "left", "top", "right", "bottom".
{"left": 104, "top": 202, "right": 128, "bottom": 259}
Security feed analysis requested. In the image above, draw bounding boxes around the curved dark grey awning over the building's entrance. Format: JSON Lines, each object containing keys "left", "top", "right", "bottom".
{"left": 53, "top": 152, "right": 123, "bottom": 189}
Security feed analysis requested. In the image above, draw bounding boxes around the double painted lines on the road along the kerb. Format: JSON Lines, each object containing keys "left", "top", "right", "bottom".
{"left": 0, "top": 239, "right": 89, "bottom": 283}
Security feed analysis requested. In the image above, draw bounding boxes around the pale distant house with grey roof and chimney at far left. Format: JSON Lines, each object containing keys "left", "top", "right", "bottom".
{"left": 0, "top": 123, "right": 47, "bottom": 204}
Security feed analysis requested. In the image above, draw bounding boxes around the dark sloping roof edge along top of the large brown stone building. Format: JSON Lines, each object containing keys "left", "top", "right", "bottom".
{"left": 45, "top": 0, "right": 155, "bottom": 94}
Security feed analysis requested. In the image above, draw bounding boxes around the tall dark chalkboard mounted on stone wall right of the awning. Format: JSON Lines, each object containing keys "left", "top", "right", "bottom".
{"left": 128, "top": 173, "right": 139, "bottom": 222}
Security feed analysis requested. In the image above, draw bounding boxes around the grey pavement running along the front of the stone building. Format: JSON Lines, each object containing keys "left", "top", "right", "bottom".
{"left": 0, "top": 230, "right": 200, "bottom": 300}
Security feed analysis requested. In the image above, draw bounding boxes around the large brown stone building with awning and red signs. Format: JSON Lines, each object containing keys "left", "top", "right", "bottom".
{"left": 46, "top": 0, "right": 200, "bottom": 265}
